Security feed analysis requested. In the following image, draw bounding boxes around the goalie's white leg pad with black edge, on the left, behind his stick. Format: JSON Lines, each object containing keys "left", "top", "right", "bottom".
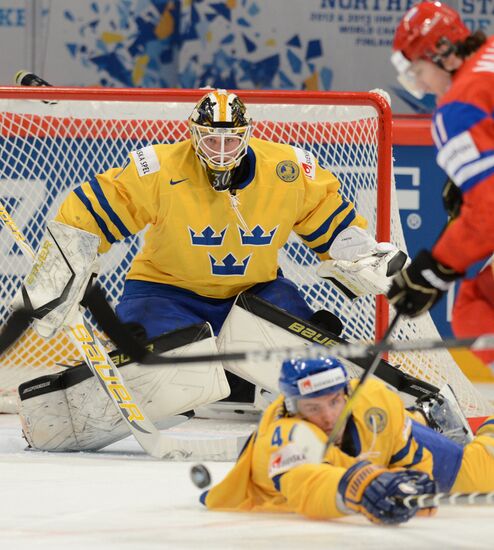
{"left": 19, "top": 323, "right": 230, "bottom": 451}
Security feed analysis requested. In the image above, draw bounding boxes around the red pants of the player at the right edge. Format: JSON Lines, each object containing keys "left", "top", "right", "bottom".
{"left": 451, "top": 267, "right": 494, "bottom": 365}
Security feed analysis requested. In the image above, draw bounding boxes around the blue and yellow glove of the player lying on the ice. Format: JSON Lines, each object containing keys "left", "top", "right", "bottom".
{"left": 338, "top": 461, "right": 436, "bottom": 524}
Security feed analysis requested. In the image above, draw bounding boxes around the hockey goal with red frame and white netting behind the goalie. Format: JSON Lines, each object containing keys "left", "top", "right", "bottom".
{"left": 0, "top": 87, "right": 492, "bottom": 416}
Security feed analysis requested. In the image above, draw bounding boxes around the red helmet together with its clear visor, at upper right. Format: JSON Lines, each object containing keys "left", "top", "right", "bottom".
{"left": 391, "top": 2, "right": 470, "bottom": 99}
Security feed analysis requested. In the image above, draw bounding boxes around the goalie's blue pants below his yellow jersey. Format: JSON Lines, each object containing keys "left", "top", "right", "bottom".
{"left": 116, "top": 275, "right": 313, "bottom": 338}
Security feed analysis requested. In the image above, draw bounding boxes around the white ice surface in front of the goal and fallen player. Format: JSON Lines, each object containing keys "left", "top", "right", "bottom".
{"left": 0, "top": 392, "right": 494, "bottom": 550}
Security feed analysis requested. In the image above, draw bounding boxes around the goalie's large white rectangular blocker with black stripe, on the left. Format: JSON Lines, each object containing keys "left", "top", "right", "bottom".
{"left": 12, "top": 221, "right": 100, "bottom": 338}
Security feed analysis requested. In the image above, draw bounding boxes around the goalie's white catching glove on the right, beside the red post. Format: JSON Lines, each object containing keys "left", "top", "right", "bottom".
{"left": 317, "top": 226, "right": 410, "bottom": 300}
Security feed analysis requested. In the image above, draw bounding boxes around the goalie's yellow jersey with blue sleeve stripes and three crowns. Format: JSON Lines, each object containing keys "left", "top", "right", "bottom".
{"left": 56, "top": 138, "right": 366, "bottom": 298}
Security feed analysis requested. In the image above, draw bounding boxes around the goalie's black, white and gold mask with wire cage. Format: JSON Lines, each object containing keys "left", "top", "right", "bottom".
{"left": 189, "top": 90, "right": 252, "bottom": 191}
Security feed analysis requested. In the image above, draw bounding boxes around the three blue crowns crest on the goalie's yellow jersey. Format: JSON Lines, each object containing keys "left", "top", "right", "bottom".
{"left": 188, "top": 225, "right": 278, "bottom": 276}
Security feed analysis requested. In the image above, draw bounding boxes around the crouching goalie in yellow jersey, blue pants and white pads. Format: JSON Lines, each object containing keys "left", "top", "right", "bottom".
{"left": 8, "top": 90, "right": 408, "bottom": 450}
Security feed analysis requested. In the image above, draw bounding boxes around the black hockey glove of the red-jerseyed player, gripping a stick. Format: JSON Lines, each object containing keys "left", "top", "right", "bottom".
{"left": 387, "top": 250, "right": 463, "bottom": 317}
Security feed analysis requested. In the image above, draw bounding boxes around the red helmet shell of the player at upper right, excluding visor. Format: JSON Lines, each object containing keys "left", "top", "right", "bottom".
{"left": 393, "top": 1, "right": 470, "bottom": 61}
